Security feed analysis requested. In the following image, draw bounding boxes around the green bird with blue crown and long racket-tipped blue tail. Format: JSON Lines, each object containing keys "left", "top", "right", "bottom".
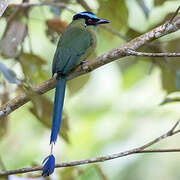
{"left": 42, "top": 11, "right": 111, "bottom": 177}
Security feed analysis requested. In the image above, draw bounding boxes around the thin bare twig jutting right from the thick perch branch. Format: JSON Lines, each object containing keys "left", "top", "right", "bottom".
{"left": 125, "top": 49, "right": 180, "bottom": 57}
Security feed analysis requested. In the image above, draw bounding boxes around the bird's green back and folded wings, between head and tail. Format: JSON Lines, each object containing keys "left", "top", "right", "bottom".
{"left": 52, "top": 25, "right": 91, "bottom": 75}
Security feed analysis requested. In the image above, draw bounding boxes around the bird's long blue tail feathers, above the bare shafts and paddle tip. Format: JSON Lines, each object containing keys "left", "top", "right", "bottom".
{"left": 50, "top": 75, "right": 66, "bottom": 144}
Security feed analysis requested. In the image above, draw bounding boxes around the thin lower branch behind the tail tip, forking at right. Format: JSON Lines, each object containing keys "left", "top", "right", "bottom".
{"left": 0, "top": 120, "right": 180, "bottom": 177}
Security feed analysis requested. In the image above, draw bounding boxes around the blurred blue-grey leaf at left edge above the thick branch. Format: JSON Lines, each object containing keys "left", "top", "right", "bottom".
{"left": 0, "top": 62, "right": 21, "bottom": 85}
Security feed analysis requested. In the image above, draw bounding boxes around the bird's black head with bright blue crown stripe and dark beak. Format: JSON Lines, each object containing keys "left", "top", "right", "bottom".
{"left": 73, "top": 12, "right": 111, "bottom": 26}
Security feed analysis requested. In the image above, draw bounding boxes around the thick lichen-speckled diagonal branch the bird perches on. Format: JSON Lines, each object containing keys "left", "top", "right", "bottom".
{"left": 0, "top": 16, "right": 180, "bottom": 119}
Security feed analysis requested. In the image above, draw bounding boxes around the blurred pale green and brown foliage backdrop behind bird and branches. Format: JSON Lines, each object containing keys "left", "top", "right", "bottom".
{"left": 0, "top": 0, "right": 180, "bottom": 180}
